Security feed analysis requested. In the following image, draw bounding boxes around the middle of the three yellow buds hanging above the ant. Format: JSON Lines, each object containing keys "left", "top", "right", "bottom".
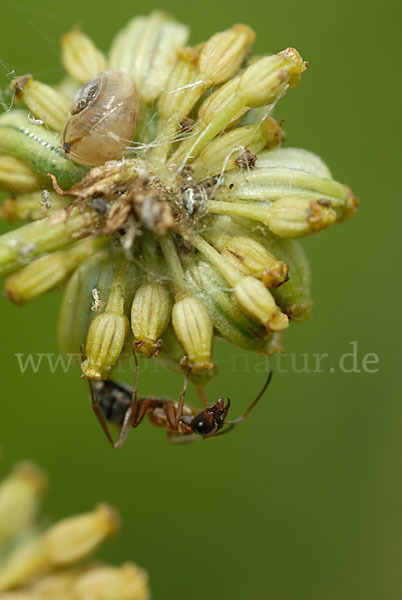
{"left": 131, "top": 282, "right": 171, "bottom": 358}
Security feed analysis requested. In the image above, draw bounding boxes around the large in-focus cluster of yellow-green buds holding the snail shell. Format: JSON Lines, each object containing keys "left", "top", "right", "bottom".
{"left": 0, "top": 12, "right": 357, "bottom": 390}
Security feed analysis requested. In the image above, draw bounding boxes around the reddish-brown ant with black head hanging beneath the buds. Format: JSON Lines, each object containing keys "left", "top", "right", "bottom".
{"left": 88, "top": 354, "right": 272, "bottom": 449}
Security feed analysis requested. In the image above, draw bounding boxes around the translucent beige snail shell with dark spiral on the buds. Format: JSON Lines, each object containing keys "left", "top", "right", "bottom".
{"left": 62, "top": 71, "right": 140, "bottom": 167}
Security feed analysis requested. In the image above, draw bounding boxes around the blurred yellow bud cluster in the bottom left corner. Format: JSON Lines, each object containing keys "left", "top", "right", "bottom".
{"left": 0, "top": 463, "right": 150, "bottom": 600}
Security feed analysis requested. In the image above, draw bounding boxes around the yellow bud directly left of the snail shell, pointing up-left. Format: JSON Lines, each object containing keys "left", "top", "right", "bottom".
{"left": 11, "top": 75, "right": 70, "bottom": 132}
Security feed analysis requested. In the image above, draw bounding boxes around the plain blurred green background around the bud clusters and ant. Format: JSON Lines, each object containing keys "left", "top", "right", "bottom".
{"left": 0, "top": 0, "right": 402, "bottom": 600}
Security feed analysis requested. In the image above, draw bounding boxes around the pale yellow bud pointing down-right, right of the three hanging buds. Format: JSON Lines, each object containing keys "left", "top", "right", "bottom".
{"left": 234, "top": 276, "right": 288, "bottom": 331}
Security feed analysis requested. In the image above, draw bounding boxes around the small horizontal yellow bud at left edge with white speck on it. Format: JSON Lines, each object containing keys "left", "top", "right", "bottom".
{"left": 0, "top": 191, "right": 72, "bottom": 223}
